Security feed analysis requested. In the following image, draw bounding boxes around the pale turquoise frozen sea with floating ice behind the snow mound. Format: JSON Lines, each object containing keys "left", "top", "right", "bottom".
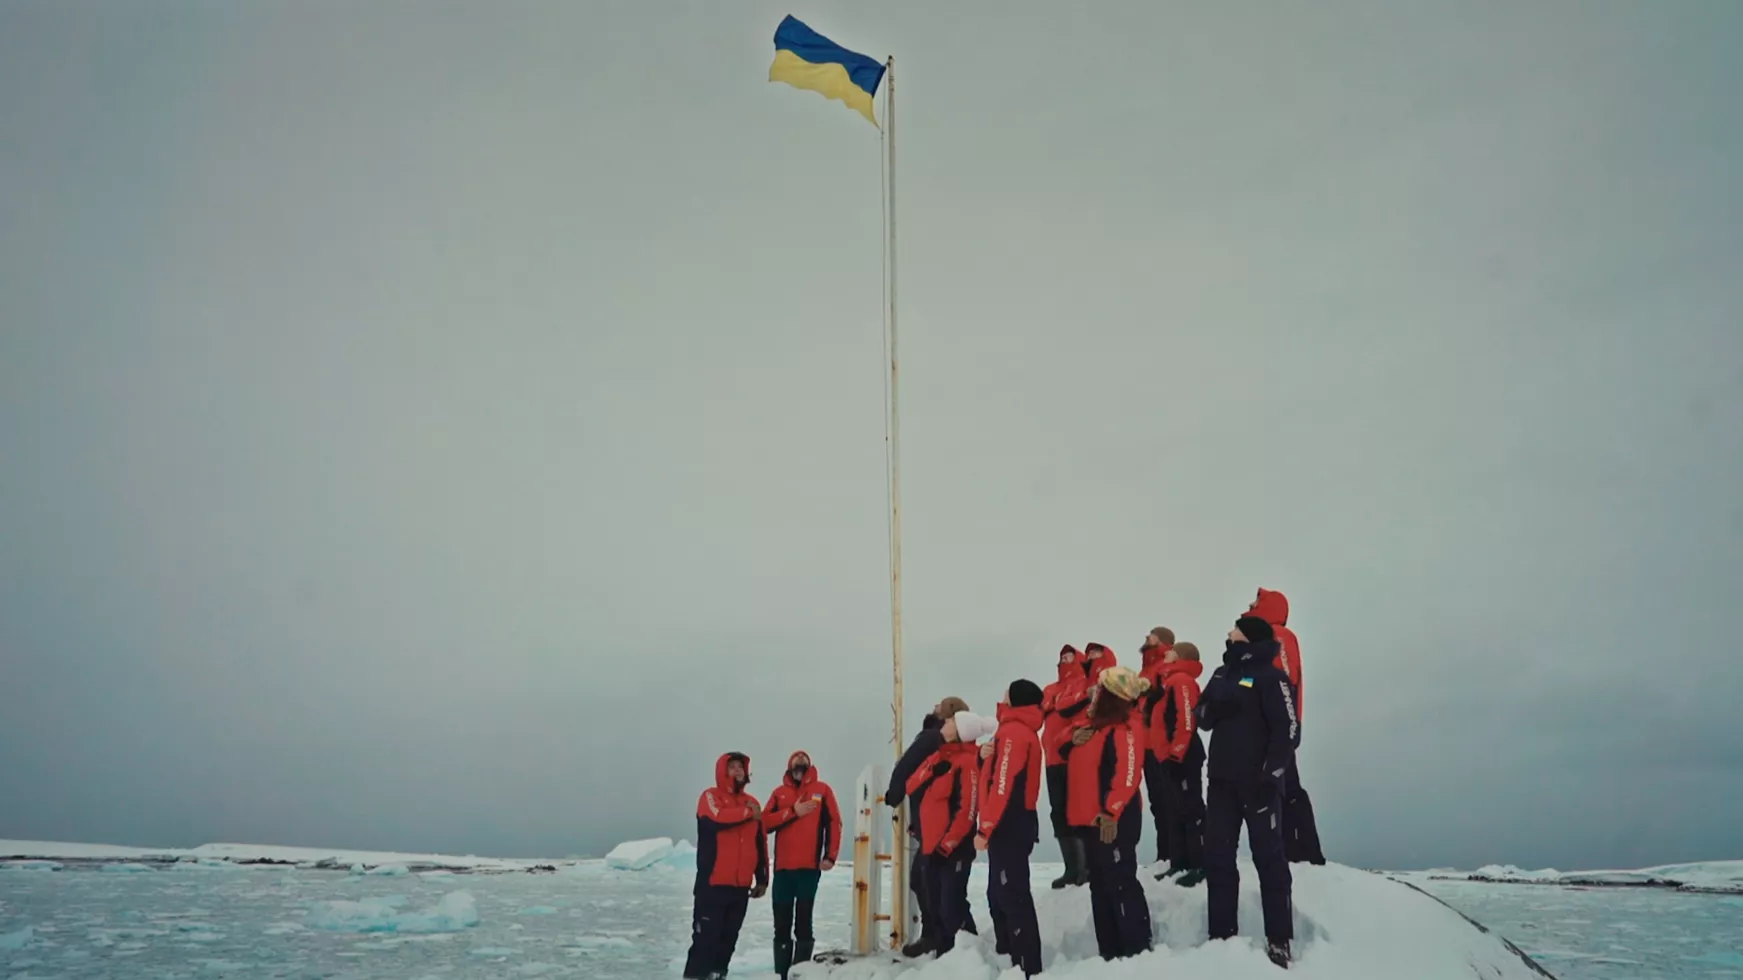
{"left": 0, "top": 861, "right": 1743, "bottom": 980}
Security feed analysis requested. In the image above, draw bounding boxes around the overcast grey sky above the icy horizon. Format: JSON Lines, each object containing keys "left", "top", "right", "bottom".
{"left": 0, "top": 0, "right": 1743, "bottom": 867}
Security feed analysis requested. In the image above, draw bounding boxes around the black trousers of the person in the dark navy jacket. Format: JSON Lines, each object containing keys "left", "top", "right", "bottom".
{"left": 1204, "top": 779, "right": 1295, "bottom": 940}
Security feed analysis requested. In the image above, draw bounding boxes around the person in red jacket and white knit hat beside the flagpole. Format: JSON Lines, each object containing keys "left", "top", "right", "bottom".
{"left": 901, "top": 711, "right": 994, "bottom": 957}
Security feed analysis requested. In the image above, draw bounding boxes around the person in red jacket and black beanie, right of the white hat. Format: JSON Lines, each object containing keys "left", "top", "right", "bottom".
{"left": 974, "top": 680, "right": 1042, "bottom": 977}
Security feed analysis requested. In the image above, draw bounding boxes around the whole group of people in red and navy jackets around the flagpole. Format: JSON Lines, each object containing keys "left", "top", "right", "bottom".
{"left": 683, "top": 589, "right": 1325, "bottom": 980}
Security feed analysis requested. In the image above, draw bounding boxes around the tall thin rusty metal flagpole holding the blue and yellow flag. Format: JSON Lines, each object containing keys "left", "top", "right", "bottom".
{"left": 884, "top": 56, "right": 908, "bottom": 949}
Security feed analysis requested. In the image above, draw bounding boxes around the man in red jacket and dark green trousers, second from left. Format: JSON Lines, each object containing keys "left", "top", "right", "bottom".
{"left": 762, "top": 752, "right": 842, "bottom": 980}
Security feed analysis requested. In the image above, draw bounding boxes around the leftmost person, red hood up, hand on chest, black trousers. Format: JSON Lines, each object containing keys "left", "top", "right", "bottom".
{"left": 683, "top": 752, "right": 769, "bottom": 980}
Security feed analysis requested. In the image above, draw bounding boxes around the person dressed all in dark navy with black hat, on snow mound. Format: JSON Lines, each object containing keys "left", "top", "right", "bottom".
{"left": 1197, "top": 616, "right": 1300, "bottom": 970}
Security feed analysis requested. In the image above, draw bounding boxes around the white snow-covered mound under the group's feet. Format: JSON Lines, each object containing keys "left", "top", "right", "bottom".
{"left": 793, "top": 865, "right": 1550, "bottom": 980}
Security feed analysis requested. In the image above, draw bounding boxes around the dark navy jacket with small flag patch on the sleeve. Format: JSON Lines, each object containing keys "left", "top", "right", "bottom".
{"left": 1197, "top": 640, "right": 1300, "bottom": 785}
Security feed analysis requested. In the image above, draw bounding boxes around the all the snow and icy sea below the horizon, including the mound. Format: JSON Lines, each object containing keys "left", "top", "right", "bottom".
{"left": 0, "top": 842, "right": 1743, "bottom": 980}
